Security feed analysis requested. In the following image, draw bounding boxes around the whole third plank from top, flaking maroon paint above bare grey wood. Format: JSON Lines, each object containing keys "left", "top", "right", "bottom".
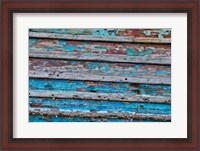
{"left": 29, "top": 58, "right": 171, "bottom": 84}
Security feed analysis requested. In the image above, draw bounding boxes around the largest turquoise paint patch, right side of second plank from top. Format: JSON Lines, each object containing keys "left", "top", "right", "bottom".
{"left": 126, "top": 48, "right": 153, "bottom": 56}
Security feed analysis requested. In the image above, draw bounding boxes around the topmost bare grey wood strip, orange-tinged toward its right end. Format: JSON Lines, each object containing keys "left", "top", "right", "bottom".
{"left": 29, "top": 31, "right": 171, "bottom": 44}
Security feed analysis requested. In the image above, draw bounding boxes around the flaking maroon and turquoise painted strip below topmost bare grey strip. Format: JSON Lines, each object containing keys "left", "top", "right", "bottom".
{"left": 29, "top": 38, "right": 171, "bottom": 57}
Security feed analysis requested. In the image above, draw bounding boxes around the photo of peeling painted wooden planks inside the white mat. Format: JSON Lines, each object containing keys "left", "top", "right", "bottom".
{"left": 28, "top": 29, "right": 171, "bottom": 122}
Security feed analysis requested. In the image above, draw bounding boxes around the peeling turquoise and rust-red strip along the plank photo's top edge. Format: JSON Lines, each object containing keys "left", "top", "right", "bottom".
{"left": 30, "top": 28, "right": 171, "bottom": 38}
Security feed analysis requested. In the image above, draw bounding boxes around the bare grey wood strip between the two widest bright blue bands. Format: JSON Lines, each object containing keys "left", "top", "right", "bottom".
{"left": 29, "top": 90, "right": 171, "bottom": 103}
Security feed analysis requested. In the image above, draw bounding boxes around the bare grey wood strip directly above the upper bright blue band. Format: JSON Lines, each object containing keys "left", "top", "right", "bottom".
{"left": 29, "top": 70, "right": 171, "bottom": 84}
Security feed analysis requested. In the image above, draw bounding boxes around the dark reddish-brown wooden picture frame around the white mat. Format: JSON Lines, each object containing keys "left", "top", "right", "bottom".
{"left": 0, "top": 0, "right": 200, "bottom": 151}
